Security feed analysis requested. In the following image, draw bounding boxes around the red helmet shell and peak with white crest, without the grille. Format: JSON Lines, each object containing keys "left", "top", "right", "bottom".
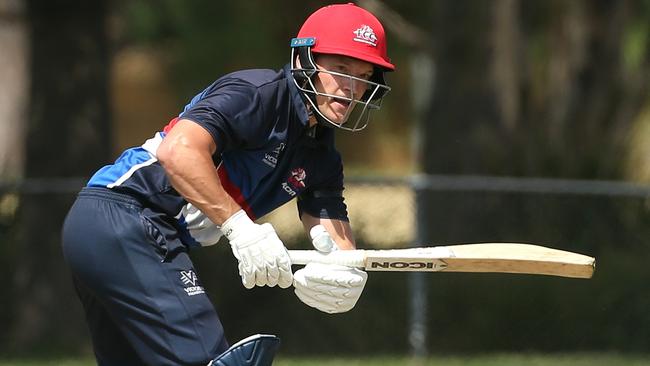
{"left": 297, "top": 3, "right": 395, "bottom": 71}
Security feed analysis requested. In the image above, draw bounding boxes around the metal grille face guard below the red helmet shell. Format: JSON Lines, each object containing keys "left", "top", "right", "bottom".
{"left": 291, "top": 37, "right": 390, "bottom": 131}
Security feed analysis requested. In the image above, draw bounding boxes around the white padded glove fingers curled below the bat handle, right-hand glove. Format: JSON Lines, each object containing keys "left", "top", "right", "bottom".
{"left": 293, "top": 263, "right": 368, "bottom": 314}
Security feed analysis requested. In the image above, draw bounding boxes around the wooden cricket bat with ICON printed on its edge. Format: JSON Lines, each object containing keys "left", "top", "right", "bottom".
{"left": 289, "top": 243, "right": 596, "bottom": 278}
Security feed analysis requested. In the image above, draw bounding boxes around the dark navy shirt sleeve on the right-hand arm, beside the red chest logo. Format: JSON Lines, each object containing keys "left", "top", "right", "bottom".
{"left": 298, "top": 153, "right": 349, "bottom": 222}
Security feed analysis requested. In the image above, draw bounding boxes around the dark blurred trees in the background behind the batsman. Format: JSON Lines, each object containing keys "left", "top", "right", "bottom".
{"left": 0, "top": 0, "right": 650, "bottom": 360}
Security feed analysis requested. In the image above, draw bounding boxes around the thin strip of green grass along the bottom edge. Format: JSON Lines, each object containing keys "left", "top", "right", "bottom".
{"left": 0, "top": 353, "right": 650, "bottom": 366}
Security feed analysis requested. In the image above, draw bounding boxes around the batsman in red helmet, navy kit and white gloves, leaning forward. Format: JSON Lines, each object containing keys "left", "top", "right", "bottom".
{"left": 62, "top": 3, "right": 394, "bottom": 366}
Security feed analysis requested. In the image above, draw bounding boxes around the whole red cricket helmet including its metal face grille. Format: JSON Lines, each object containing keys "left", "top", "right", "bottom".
{"left": 291, "top": 3, "right": 395, "bottom": 131}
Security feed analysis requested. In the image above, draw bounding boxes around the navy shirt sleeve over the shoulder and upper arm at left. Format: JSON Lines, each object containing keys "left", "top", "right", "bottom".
{"left": 180, "top": 79, "right": 272, "bottom": 155}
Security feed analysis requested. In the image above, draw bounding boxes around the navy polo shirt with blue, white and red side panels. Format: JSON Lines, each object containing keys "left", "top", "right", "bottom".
{"left": 88, "top": 66, "right": 348, "bottom": 245}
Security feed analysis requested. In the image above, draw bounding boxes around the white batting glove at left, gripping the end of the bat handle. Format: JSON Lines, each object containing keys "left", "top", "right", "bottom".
{"left": 221, "top": 210, "right": 293, "bottom": 289}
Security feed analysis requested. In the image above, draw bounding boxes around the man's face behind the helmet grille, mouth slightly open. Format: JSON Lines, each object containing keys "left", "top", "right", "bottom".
{"left": 314, "top": 54, "right": 374, "bottom": 124}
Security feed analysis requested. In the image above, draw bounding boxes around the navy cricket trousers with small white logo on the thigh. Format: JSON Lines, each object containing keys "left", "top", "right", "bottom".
{"left": 63, "top": 188, "right": 228, "bottom": 366}
